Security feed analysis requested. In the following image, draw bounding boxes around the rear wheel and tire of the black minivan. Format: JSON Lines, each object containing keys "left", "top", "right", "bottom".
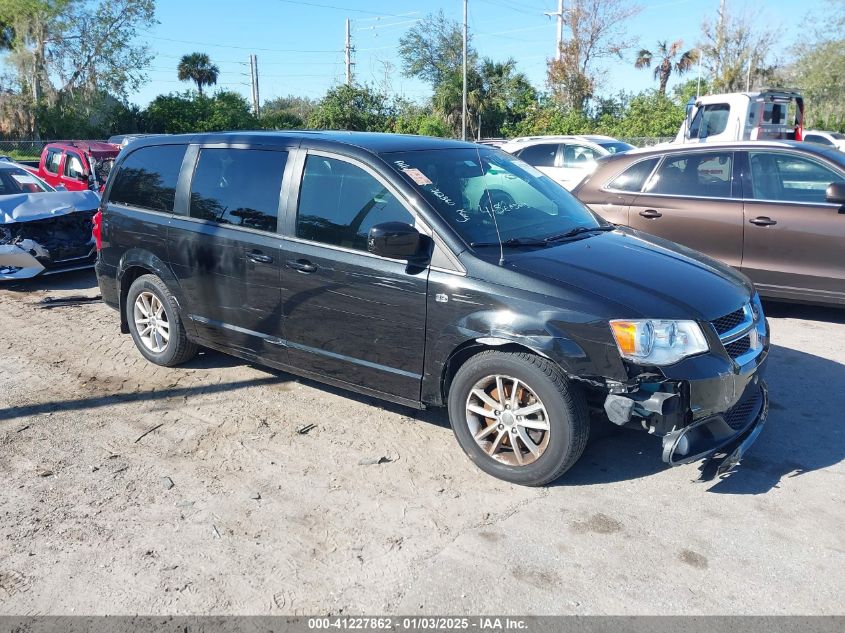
{"left": 124, "top": 275, "right": 198, "bottom": 367}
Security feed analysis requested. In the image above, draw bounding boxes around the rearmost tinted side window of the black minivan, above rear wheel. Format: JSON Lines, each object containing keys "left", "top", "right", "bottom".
{"left": 109, "top": 145, "right": 186, "bottom": 213}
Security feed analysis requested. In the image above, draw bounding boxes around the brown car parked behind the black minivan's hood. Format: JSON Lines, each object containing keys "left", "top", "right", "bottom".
{"left": 573, "top": 141, "right": 845, "bottom": 305}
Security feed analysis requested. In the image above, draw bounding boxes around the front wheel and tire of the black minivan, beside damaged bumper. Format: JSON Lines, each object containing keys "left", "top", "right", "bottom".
{"left": 449, "top": 351, "right": 590, "bottom": 486}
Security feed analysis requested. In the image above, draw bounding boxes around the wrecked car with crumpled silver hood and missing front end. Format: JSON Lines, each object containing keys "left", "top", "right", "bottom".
{"left": 0, "top": 162, "right": 100, "bottom": 281}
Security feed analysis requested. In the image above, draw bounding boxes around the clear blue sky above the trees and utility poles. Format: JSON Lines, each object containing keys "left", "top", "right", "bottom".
{"left": 135, "top": 0, "right": 824, "bottom": 106}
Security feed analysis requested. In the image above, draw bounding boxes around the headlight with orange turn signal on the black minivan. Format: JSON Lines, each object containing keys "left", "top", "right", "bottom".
{"left": 610, "top": 319, "right": 710, "bottom": 365}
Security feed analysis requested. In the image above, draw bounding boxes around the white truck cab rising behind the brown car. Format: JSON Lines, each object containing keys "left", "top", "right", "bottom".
{"left": 675, "top": 90, "right": 804, "bottom": 143}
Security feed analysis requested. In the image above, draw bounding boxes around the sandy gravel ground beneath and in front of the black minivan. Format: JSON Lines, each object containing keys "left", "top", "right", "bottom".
{"left": 0, "top": 272, "right": 845, "bottom": 614}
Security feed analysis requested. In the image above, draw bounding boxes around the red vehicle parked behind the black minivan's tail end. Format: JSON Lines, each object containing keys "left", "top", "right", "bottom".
{"left": 33, "top": 141, "right": 120, "bottom": 191}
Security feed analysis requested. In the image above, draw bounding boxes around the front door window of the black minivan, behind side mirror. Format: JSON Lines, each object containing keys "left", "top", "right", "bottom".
{"left": 296, "top": 154, "right": 414, "bottom": 251}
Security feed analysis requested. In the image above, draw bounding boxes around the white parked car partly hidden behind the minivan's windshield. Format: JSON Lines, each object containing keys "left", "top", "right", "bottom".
{"left": 502, "top": 135, "right": 634, "bottom": 189}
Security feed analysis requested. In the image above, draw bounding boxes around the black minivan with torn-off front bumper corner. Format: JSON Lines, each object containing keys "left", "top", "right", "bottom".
{"left": 95, "top": 132, "right": 769, "bottom": 485}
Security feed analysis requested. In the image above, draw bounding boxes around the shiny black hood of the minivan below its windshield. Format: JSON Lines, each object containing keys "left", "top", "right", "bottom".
{"left": 507, "top": 227, "right": 753, "bottom": 321}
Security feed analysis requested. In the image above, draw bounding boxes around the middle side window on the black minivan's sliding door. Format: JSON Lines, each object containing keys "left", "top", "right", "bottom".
{"left": 190, "top": 148, "right": 287, "bottom": 231}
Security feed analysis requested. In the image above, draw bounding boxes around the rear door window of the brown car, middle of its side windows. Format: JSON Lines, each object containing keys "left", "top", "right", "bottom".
{"left": 645, "top": 152, "right": 733, "bottom": 198}
